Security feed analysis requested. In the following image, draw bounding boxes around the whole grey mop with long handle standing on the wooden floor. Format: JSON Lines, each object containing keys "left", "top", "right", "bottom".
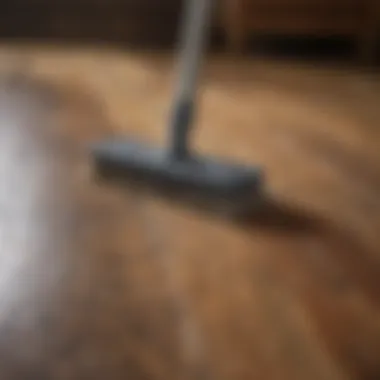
{"left": 92, "top": 0, "right": 262, "bottom": 205}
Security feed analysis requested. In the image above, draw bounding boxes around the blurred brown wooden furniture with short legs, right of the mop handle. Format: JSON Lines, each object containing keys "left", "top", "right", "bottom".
{"left": 222, "top": 0, "right": 379, "bottom": 57}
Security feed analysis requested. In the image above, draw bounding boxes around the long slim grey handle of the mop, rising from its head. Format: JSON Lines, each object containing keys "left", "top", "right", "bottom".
{"left": 169, "top": 0, "right": 212, "bottom": 159}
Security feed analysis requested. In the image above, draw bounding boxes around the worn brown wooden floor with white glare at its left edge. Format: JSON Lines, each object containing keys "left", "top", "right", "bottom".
{"left": 0, "top": 45, "right": 380, "bottom": 380}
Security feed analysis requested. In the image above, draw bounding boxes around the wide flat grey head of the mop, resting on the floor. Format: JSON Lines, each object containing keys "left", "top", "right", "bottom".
{"left": 93, "top": 138, "right": 262, "bottom": 206}
